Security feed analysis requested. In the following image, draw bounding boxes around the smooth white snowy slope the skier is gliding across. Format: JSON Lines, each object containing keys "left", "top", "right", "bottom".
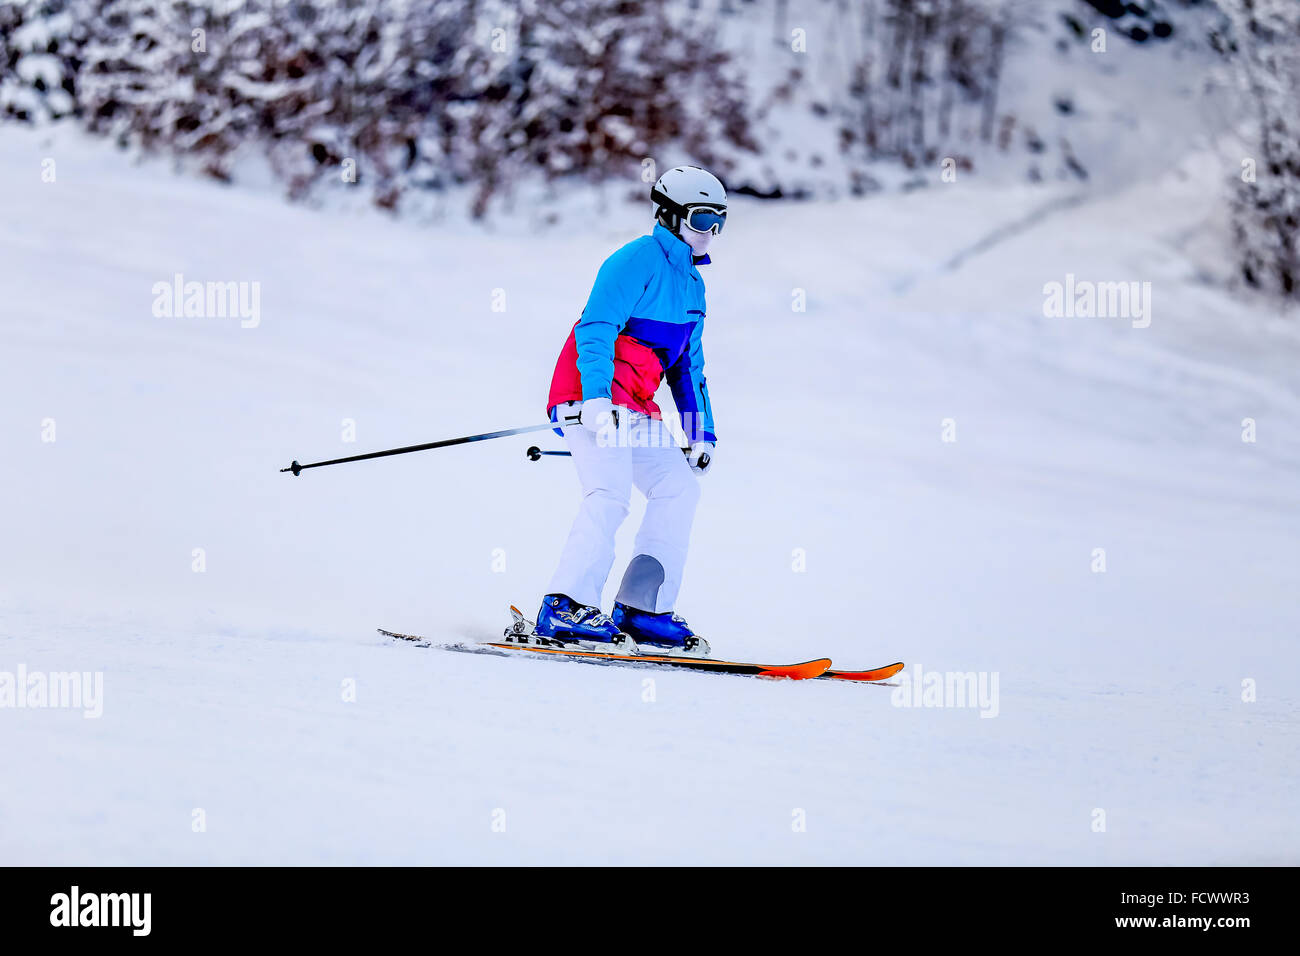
{"left": 0, "top": 123, "right": 1300, "bottom": 864}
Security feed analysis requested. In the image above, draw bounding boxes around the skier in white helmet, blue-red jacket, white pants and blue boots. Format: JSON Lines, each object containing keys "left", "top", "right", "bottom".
{"left": 536, "top": 166, "right": 727, "bottom": 657}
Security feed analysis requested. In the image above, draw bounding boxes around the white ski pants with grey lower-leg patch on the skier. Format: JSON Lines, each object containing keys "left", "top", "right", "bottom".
{"left": 547, "top": 408, "right": 699, "bottom": 614}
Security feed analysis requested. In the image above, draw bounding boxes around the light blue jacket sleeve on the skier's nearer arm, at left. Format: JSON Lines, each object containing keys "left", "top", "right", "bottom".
{"left": 573, "top": 243, "right": 653, "bottom": 401}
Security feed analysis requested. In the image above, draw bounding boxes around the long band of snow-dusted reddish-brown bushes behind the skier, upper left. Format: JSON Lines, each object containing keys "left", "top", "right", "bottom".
{"left": 0, "top": 0, "right": 753, "bottom": 213}
